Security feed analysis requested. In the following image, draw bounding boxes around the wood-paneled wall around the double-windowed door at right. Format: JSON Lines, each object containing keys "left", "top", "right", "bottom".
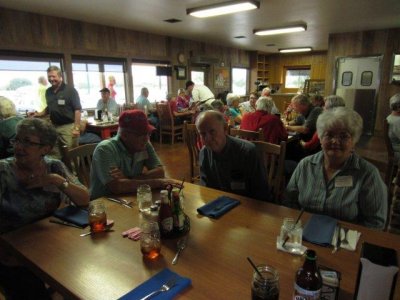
{"left": 325, "top": 28, "right": 400, "bottom": 135}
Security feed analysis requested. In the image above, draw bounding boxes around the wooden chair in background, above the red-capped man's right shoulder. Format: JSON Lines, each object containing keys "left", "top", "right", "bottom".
{"left": 156, "top": 102, "right": 183, "bottom": 145}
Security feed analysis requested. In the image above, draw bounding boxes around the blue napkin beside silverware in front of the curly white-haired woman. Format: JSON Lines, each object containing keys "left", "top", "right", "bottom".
{"left": 303, "top": 215, "right": 337, "bottom": 247}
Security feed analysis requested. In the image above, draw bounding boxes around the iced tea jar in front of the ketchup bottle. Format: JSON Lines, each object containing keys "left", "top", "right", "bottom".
{"left": 140, "top": 222, "right": 161, "bottom": 259}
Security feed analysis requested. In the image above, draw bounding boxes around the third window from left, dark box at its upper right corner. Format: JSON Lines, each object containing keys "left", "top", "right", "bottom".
{"left": 132, "top": 63, "right": 168, "bottom": 102}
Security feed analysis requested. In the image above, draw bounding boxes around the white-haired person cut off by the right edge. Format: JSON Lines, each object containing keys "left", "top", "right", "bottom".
{"left": 386, "top": 93, "right": 400, "bottom": 160}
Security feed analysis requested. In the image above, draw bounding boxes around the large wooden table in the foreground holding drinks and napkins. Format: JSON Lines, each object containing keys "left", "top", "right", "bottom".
{"left": 0, "top": 183, "right": 400, "bottom": 300}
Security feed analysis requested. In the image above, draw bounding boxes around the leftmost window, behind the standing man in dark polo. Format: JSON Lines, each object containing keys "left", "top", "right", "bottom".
{"left": 0, "top": 56, "right": 61, "bottom": 113}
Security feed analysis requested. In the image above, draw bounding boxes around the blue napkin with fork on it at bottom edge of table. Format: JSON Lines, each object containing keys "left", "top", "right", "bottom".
{"left": 119, "top": 268, "right": 192, "bottom": 300}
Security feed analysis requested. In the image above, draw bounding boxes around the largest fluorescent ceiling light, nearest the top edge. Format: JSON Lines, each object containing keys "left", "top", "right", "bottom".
{"left": 186, "top": 0, "right": 260, "bottom": 18}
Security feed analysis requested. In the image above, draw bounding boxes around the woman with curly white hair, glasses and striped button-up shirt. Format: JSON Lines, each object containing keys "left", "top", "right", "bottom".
{"left": 284, "top": 107, "right": 387, "bottom": 229}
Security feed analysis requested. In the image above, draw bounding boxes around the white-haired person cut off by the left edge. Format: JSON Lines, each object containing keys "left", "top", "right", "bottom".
{"left": 0, "top": 96, "right": 22, "bottom": 159}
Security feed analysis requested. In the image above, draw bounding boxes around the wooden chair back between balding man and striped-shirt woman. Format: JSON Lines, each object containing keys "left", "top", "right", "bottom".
{"left": 253, "top": 141, "right": 286, "bottom": 203}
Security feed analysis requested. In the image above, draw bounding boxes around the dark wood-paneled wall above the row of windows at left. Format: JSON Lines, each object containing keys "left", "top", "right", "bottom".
{"left": 0, "top": 8, "right": 250, "bottom": 101}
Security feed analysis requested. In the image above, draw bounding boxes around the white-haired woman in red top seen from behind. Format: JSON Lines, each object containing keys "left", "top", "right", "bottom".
{"left": 240, "top": 97, "right": 288, "bottom": 145}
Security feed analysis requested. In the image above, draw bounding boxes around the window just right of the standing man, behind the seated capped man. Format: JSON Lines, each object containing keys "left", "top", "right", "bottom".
{"left": 72, "top": 58, "right": 126, "bottom": 108}
